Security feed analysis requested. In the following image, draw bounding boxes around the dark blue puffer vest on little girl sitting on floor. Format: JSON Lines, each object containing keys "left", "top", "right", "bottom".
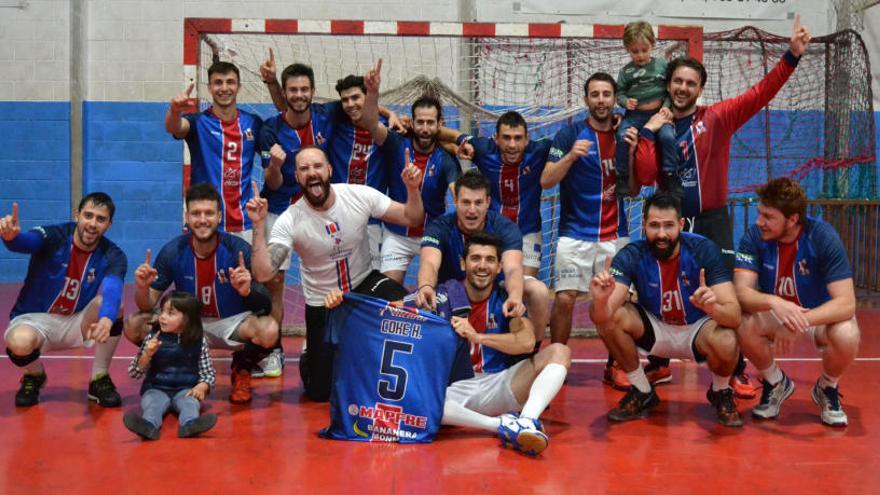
{"left": 141, "top": 332, "right": 202, "bottom": 394}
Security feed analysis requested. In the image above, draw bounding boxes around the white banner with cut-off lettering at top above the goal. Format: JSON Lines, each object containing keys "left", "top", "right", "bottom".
{"left": 520, "top": 0, "right": 795, "bottom": 20}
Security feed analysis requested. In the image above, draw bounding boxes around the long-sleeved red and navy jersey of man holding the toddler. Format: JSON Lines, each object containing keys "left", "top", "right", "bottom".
{"left": 634, "top": 52, "right": 799, "bottom": 217}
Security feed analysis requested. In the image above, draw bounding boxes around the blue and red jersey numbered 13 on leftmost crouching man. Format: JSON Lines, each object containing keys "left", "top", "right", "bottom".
{"left": 4, "top": 222, "right": 128, "bottom": 320}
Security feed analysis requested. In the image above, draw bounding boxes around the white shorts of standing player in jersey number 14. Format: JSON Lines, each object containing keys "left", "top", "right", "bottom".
{"left": 554, "top": 237, "right": 629, "bottom": 292}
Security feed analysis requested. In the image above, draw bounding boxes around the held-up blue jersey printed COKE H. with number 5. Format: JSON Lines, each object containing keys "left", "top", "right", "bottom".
{"left": 321, "top": 293, "right": 460, "bottom": 443}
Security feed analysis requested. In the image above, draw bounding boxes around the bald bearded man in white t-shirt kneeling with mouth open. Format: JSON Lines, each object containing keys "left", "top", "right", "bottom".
{"left": 247, "top": 146, "right": 425, "bottom": 401}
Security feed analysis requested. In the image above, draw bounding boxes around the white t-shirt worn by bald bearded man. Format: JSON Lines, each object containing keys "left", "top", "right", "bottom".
{"left": 269, "top": 184, "right": 391, "bottom": 306}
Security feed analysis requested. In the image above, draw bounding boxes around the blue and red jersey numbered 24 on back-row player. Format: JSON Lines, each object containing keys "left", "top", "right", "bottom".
{"left": 326, "top": 102, "right": 397, "bottom": 193}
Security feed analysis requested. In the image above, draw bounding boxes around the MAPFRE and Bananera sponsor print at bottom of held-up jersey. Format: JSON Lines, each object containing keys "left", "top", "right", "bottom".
{"left": 348, "top": 402, "right": 428, "bottom": 442}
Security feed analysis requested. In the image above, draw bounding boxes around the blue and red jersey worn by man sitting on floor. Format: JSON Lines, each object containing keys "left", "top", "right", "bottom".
{"left": 437, "top": 280, "right": 511, "bottom": 373}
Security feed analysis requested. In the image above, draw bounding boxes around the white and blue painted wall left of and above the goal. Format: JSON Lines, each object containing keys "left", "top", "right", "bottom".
{"left": 0, "top": 0, "right": 878, "bottom": 282}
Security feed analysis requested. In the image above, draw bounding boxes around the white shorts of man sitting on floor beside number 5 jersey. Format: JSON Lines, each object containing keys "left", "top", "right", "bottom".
{"left": 446, "top": 360, "right": 527, "bottom": 416}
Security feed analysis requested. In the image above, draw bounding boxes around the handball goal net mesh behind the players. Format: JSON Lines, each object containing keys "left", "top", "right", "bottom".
{"left": 198, "top": 28, "right": 876, "bottom": 327}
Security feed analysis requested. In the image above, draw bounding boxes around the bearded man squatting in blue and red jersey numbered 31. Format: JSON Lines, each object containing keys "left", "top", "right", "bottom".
{"left": 590, "top": 192, "right": 742, "bottom": 426}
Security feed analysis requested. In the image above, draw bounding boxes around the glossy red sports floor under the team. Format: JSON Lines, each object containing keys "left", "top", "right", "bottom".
{"left": 0, "top": 292, "right": 880, "bottom": 494}
